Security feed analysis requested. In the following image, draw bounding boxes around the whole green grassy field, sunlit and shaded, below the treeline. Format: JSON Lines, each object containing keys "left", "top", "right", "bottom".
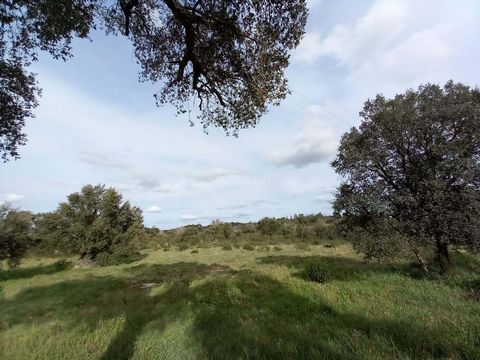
{"left": 0, "top": 245, "right": 480, "bottom": 360}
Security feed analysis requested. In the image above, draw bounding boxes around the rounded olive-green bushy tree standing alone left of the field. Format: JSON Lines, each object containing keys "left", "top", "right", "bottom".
{"left": 37, "top": 185, "right": 143, "bottom": 262}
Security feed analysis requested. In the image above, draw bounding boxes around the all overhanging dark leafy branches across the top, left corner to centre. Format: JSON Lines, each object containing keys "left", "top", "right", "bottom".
{"left": 0, "top": 0, "right": 307, "bottom": 160}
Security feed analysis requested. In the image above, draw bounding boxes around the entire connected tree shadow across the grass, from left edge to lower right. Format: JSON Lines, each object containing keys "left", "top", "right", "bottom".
{"left": 0, "top": 263, "right": 478, "bottom": 359}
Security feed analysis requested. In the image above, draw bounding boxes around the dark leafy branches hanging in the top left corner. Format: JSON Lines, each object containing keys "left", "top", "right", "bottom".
{"left": 0, "top": 0, "right": 98, "bottom": 160}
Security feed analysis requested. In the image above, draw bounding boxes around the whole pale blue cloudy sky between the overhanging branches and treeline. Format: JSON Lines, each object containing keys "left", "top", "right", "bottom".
{"left": 0, "top": 0, "right": 480, "bottom": 229}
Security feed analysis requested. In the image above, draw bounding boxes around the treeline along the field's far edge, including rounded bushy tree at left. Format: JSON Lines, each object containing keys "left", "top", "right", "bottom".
{"left": 0, "top": 185, "right": 340, "bottom": 267}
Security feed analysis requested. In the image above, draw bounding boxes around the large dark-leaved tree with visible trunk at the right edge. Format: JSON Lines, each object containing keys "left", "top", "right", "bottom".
{"left": 332, "top": 81, "right": 480, "bottom": 271}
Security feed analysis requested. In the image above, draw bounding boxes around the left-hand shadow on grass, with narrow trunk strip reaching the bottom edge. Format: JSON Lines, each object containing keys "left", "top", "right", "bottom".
{"left": 0, "top": 262, "right": 231, "bottom": 359}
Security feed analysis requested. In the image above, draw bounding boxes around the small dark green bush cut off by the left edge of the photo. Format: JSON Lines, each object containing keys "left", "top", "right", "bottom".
{"left": 0, "top": 204, "right": 33, "bottom": 267}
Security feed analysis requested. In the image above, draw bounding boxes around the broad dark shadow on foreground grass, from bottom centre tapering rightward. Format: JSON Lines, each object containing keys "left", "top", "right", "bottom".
{"left": 185, "top": 271, "right": 462, "bottom": 359}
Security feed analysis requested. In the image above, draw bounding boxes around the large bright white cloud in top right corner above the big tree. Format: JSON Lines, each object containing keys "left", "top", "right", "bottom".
{"left": 294, "top": 0, "right": 480, "bottom": 91}
